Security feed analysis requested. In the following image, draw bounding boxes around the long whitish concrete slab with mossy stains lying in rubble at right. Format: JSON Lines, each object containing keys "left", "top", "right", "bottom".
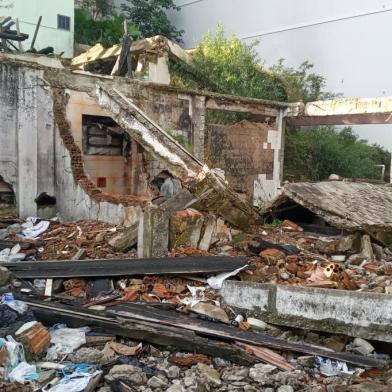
{"left": 221, "top": 281, "right": 392, "bottom": 342}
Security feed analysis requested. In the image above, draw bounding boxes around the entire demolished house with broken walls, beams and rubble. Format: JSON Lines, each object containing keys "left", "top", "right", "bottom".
{"left": 0, "top": 37, "right": 392, "bottom": 392}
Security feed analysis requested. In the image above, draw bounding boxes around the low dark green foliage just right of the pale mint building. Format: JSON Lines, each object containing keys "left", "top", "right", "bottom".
{"left": 75, "top": 9, "right": 139, "bottom": 47}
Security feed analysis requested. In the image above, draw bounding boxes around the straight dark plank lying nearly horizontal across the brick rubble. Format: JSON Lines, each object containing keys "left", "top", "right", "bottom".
{"left": 0, "top": 256, "right": 247, "bottom": 279}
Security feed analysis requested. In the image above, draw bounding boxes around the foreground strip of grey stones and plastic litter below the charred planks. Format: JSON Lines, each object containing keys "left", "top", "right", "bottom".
{"left": 0, "top": 297, "right": 392, "bottom": 392}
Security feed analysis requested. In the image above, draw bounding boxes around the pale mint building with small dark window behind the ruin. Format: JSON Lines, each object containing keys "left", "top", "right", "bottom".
{"left": 0, "top": 0, "right": 75, "bottom": 58}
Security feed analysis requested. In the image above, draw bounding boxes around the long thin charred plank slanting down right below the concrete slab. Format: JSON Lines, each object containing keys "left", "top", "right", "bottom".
{"left": 108, "top": 303, "right": 387, "bottom": 368}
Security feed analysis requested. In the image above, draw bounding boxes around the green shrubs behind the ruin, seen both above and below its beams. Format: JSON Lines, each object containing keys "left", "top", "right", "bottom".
{"left": 171, "top": 27, "right": 390, "bottom": 181}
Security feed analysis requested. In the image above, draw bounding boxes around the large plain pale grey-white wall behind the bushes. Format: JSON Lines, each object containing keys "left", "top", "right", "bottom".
{"left": 170, "top": 0, "right": 392, "bottom": 147}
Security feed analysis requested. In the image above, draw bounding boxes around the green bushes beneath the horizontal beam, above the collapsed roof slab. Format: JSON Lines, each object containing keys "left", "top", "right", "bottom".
{"left": 284, "top": 127, "right": 390, "bottom": 181}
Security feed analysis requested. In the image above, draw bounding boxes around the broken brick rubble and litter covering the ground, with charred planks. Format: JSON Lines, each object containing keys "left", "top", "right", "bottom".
{"left": 0, "top": 216, "right": 392, "bottom": 392}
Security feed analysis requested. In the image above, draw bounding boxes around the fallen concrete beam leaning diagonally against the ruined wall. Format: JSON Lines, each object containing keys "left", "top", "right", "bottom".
{"left": 96, "top": 86, "right": 260, "bottom": 229}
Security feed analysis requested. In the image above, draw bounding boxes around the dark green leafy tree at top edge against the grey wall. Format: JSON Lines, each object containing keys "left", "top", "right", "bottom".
{"left": 121, "top": 0, "right": 183, "bottom": 42}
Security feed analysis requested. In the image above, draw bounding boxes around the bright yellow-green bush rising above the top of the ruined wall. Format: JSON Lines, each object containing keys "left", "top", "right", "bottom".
{"left": 171, "top": 26, "right": 287, "bottom": 101}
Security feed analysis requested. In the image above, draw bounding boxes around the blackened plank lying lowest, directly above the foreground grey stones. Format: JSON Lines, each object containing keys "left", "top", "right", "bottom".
{"left": 21, "top": 297, "right": 258, "bottom": 366}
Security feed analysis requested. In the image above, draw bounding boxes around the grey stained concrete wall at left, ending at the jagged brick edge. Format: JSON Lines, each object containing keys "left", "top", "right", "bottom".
{"left": 0, "top": 59, "right": 141, "bottom": 225}
